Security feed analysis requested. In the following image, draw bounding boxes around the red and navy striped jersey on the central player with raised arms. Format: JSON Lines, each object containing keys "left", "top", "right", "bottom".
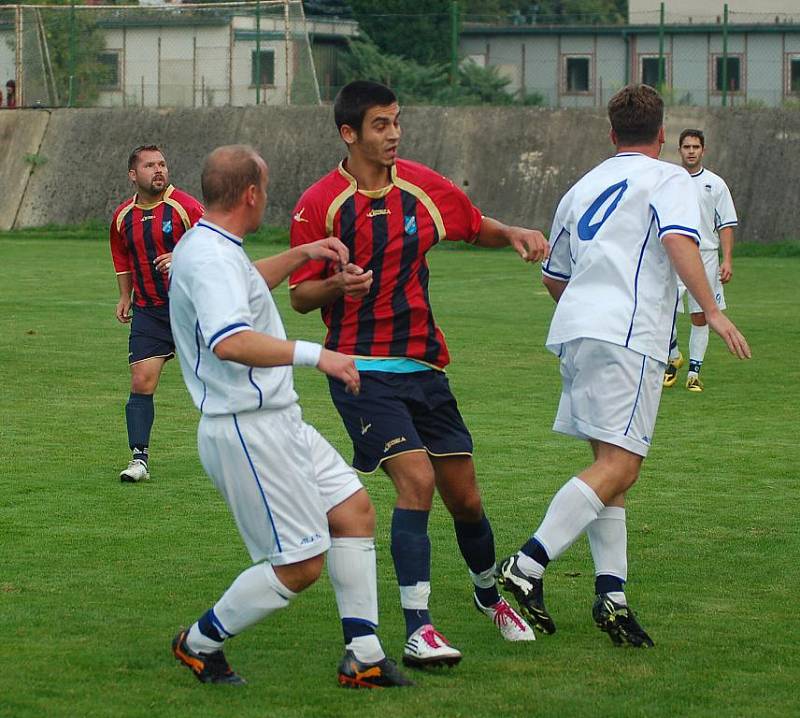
{"left": 289, "top": 160, "right": 482, "bottom": 368}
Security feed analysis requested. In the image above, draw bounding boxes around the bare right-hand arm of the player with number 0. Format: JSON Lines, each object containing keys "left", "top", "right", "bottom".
{"left": 661, "top": 234, "right": 751, "bottom": 359}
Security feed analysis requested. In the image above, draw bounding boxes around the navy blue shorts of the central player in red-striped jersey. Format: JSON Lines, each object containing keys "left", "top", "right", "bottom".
{"left": 328, "top": 370, "right": 472, "bottom": 474}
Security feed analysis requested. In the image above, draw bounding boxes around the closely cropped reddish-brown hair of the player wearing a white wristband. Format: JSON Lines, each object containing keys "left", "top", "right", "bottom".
{"left": 200, "top": 145, "right": 261, "bottom": 210}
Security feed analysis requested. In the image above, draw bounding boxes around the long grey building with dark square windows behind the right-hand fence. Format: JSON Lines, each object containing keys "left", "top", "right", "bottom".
{"left": 461, "top": 4, "right": 800, "bottom": 107}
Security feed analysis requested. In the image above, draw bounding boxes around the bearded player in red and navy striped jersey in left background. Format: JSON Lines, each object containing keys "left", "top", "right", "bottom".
{"left": 109, "top": 145, "right": 203, "bottom": 482}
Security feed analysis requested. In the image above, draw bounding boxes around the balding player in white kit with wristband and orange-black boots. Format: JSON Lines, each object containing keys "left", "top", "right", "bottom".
{"left": 170, "top": 145, "right": 411, "bottom": 688}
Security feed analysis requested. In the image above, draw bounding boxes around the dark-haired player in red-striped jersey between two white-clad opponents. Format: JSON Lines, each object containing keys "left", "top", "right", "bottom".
{"left": 290, "top": 81, "right": 547, "bottom": 667}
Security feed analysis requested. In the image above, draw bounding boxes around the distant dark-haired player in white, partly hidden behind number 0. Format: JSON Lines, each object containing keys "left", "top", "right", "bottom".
{"left": 664, "top": 129, "right": 738, "bottom": 392}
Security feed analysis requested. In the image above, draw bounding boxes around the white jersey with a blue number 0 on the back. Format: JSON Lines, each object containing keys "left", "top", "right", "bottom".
{"left": 542, "top": 152, "right": 700, "bottom": 362}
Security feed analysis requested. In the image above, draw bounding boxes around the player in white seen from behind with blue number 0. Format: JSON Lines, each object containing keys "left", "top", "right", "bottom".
{"left": 498, "top": 85, "right": 750, "bottom": 647}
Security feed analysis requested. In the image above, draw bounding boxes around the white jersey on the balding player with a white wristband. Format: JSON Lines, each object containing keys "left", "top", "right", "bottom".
{"left": 169, "top": 219, "right": 297, "bottom": 416}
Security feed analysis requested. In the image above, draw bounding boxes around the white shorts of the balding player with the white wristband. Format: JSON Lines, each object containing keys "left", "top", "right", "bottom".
{"left": 197, "top": 404, "right": 361, "bottom": 565}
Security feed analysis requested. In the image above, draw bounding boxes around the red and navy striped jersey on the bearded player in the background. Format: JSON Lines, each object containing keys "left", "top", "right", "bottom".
{"left": 109, "top": 185, "right": 205, "bottom": 307}
